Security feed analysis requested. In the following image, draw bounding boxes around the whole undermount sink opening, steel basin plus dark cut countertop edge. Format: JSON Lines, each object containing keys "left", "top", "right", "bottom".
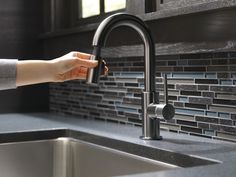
{"left": 0, "top": 130, "right": 219, "bottom": 177}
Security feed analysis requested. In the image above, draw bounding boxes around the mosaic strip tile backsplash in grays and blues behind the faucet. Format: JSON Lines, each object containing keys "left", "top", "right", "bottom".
{"left": 50, "top": 52, "right": 236, "bottom": 141}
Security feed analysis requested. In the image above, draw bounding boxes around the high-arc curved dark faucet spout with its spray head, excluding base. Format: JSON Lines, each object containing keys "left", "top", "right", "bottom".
{"left": 87, "top": 13, "right": 156, "bottom": 92}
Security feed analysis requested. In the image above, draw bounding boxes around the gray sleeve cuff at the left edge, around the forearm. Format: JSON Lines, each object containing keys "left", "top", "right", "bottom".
{"left": 0, "top": 59, "right": 17, "bottom": 90}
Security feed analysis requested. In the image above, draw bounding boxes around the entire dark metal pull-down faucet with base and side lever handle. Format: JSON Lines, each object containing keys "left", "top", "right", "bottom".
{"left": 87, "top": 13, "right": 175, "bottom": 140}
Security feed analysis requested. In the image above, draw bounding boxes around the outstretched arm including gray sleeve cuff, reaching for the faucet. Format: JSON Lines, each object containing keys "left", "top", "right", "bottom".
{"left": 0, "top": 52, "right": 97, "bottom": 90}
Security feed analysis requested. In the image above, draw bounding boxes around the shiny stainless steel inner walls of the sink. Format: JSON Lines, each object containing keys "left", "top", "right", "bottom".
{"left": 0, "top": 138, "right": 177, "bottom": 177}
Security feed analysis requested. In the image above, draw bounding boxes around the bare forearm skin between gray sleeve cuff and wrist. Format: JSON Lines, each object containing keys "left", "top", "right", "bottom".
{"left": 16, "top": 60, "right": 53, "bottom": 87}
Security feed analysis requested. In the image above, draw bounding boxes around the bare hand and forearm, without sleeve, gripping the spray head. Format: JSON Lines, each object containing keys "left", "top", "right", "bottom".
{"left": 16, "top": 52, "right": 108, "bottom": 86}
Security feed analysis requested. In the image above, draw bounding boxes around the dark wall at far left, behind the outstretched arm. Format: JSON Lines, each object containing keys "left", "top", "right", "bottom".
{"left": 0, "top": 0, "right": 48, "bottom": 113}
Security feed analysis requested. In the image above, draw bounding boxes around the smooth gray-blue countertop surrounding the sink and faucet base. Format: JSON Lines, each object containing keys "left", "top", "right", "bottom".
{"left": 0, "top": 113, "right": 236, "bottom": 177}
